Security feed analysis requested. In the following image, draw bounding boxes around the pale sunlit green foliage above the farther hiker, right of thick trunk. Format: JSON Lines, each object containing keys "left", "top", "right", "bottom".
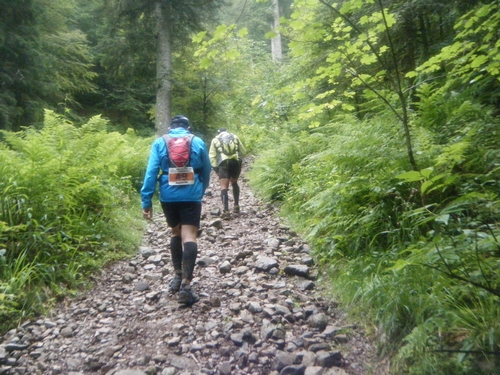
{"left": 190, "top": 20, "right": 276, "bottom": 135}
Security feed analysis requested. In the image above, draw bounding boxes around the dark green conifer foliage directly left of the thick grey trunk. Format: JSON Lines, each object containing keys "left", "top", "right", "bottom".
{"left": 73, "top": 0, "right": 156, "bottom": 134}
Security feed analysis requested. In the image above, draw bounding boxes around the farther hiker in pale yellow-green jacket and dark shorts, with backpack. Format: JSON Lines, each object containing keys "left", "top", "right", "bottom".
{"left": 208, "top": 128, "right": 246, "bottom": 219}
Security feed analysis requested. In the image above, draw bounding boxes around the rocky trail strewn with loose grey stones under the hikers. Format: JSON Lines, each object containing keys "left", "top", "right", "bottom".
{"left": 0, "top": 167, "right": 375, "bottom": 375}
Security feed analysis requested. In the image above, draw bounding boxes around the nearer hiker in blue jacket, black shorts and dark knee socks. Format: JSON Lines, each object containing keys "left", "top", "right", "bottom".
{"left": 141, "top": 116, "right": 211, "bottom": 305}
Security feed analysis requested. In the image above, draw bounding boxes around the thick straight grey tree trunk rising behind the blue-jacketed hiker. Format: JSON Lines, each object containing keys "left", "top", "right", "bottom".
{"left": 155, "top": 1, "right": 172, "bottom": 136}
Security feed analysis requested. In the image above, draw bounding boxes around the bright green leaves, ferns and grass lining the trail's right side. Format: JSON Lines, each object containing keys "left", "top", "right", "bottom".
{"left": 240, "top": 1, "right": 500, "bottom": 375}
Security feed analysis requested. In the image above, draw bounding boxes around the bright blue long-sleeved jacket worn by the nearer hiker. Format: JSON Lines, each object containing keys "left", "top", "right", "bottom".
{"left": 141, "top": 128, "right": 211, "bottom": 208}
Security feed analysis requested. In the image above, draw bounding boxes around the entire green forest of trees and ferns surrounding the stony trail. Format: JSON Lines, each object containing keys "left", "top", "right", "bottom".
{"left": 0, "top": 0, "right": 500, "bottom": 375}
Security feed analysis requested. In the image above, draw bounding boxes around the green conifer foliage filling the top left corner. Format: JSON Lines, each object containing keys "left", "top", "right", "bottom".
{"left": 0, "top": 0, "right": 96, "bottom": 130}
